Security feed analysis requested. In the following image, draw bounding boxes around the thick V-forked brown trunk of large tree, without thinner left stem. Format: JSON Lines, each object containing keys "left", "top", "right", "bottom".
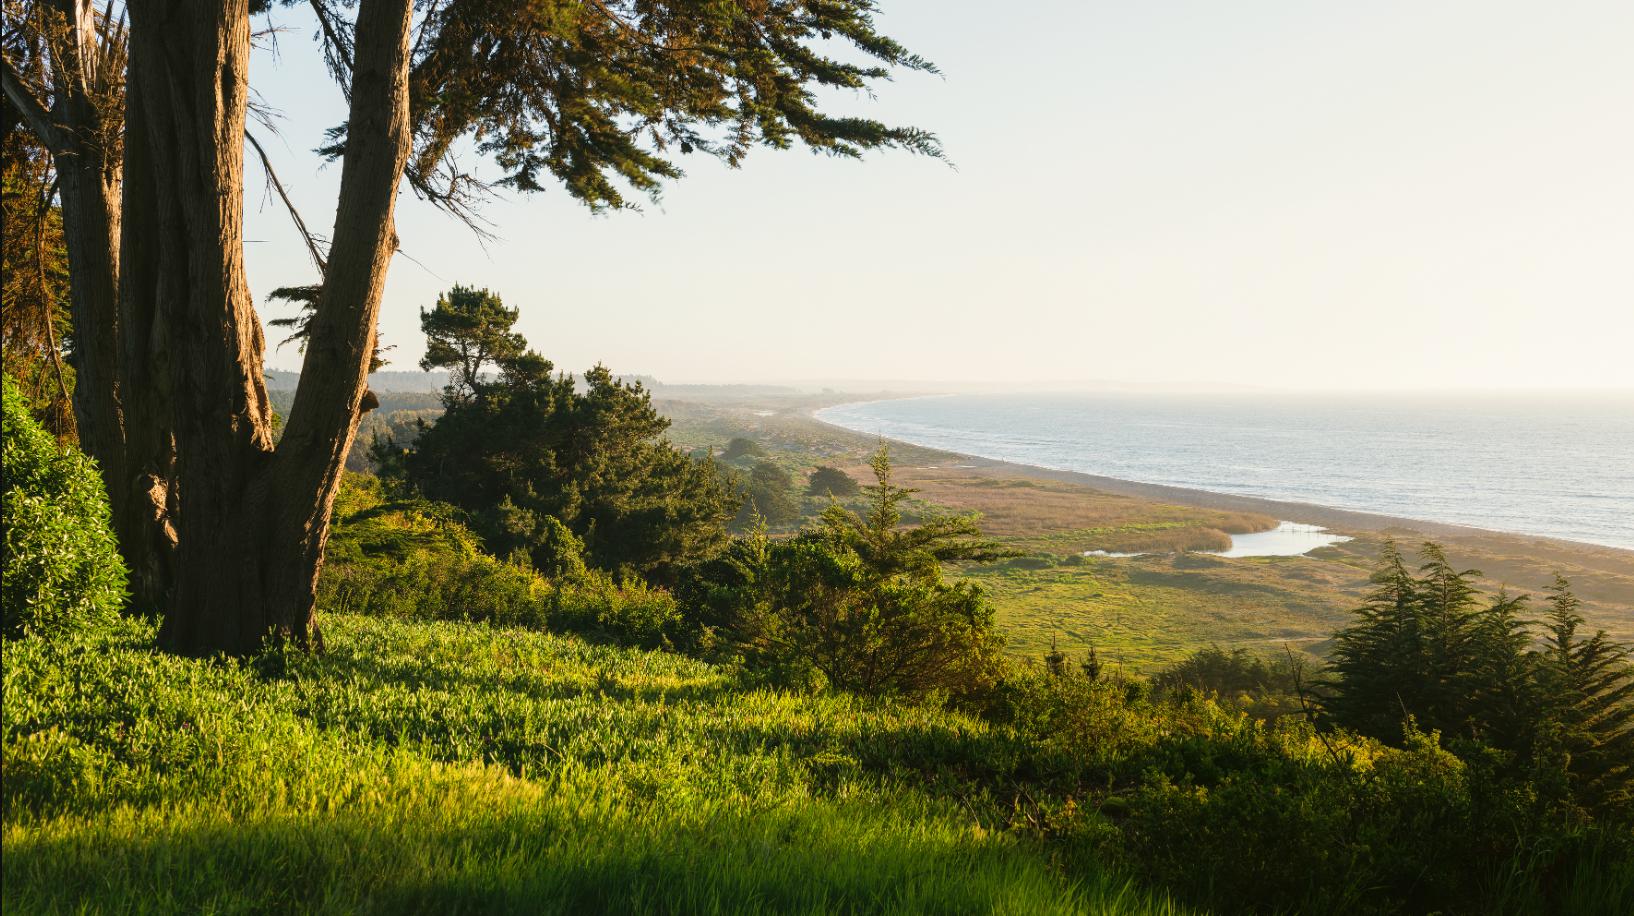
{"left": 121, "top": 0, "right": 412, "bottom": 655}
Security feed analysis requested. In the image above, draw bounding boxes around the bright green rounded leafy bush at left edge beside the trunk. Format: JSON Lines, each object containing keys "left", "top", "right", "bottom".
{"left": 0, "top": 377, "right": 126, "bottom": 638}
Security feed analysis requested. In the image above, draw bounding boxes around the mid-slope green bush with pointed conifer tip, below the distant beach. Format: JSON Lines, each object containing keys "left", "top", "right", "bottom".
{"left": 683, "top": 449, "right": 1000, "bottom": 696}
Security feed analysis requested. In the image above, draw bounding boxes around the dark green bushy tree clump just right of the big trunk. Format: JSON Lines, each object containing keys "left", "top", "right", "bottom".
{"left": 374, "top": 287, "right": 737, "bottom": 581}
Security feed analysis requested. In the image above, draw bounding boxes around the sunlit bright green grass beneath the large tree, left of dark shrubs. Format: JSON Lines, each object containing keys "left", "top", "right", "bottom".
{"left": 3, "top": 616, "right": 1196, "bottom": 914}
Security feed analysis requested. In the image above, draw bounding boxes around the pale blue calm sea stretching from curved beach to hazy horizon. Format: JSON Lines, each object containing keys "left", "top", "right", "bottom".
{"left": 817, "top": 394, "right": 1634, "bottom": 549}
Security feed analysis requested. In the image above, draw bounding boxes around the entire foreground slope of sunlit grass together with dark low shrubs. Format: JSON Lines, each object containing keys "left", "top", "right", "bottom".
{"left": 0, "top": 581, "right": 1634, "bottom": 916}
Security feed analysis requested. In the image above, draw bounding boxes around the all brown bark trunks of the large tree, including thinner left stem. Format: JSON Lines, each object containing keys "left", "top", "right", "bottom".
{"left": 5, "top": 0, "right": 413, "bottom": 655}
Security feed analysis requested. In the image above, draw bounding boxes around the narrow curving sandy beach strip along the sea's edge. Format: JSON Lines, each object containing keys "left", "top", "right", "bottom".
{"left": 806, "top": 406, "right": 1634, "bottom": 573}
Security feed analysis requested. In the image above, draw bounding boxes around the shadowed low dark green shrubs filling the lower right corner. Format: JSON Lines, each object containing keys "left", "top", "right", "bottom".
{"left": 989, "top": 671, "right": 1634, "bottom": 916}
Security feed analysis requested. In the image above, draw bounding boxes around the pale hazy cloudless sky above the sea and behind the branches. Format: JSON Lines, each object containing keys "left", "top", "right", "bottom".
{"left": 245, "top": 0, "right": 1634, "bottom": 390}
